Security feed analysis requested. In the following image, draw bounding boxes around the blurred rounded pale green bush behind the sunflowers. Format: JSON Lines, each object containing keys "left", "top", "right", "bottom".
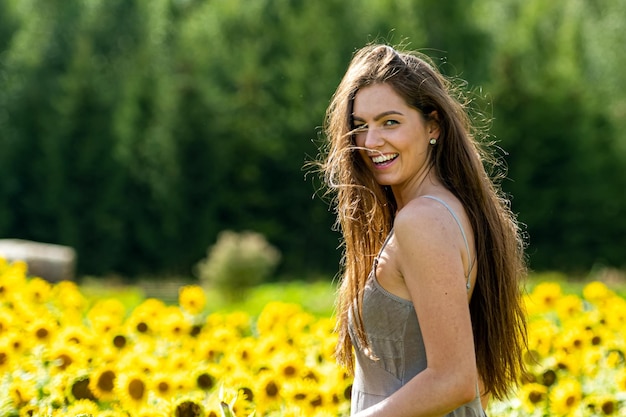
{"left": 196, "top": 230, "right": 281, "bottom": 301}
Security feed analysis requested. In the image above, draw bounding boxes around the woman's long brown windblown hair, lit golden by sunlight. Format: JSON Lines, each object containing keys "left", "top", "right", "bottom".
{"left": 319, "top": 45, "right": 526, "bottom": 399}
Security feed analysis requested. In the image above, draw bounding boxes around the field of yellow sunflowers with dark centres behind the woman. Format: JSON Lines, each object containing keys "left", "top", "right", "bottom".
{"left": 0, "top": 259, "right": 626, "bottom": 417}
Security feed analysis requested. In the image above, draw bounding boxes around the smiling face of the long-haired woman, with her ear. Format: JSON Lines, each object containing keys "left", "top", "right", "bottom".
{"left": 353, "top": 83, "right": 439, "bottom": 199}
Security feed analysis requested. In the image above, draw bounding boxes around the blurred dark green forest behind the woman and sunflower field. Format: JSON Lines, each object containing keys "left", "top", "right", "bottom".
{"left": 0, "top": 0, "right": 626, "bottom": 281}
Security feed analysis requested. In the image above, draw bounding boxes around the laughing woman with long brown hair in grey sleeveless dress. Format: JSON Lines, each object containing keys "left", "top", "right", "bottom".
{"left": 321, "top": 45, "right": 526, "bottom": 417}
